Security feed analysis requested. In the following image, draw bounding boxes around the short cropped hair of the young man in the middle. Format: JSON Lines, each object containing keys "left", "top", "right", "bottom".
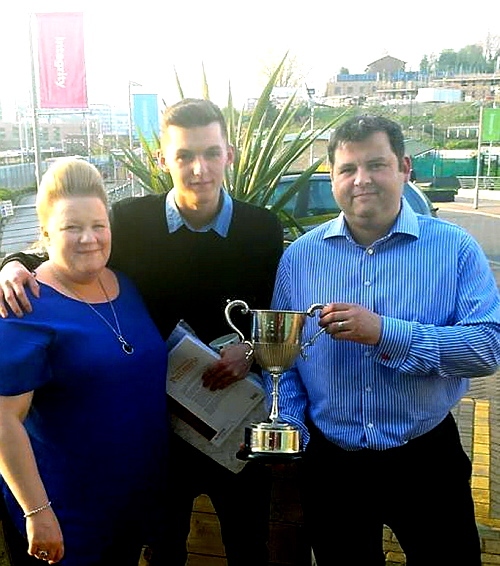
{"left": 161, "top": 98, "right": 227, "bottom": 141}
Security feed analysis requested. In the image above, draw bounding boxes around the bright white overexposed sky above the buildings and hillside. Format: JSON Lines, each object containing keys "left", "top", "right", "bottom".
{"left": 0, "top": 0, "right": 500, "bottom": 118}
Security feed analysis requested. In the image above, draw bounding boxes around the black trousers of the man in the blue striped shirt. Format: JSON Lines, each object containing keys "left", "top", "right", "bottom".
{"left": 299, "top": 414, "right": 481, "bottom": 566}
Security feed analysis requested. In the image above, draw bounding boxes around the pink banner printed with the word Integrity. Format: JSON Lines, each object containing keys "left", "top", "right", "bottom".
{"left": 36, "top": 12, "right": 88, "bottom": 108}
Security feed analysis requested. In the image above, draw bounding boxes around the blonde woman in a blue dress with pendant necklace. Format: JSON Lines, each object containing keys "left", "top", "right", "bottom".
{"left": 0, "top": 158, "right": 167, "bottom": 566}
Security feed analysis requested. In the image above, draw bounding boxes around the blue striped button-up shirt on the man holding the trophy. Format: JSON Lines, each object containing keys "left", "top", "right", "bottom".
{"left": 266, "top": 198, "right": 500, "bottom": 450}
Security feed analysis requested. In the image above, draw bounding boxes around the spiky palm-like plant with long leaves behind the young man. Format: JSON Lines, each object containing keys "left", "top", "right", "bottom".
{"left": 114, "top": 55, "right": 343, "bottom": 232}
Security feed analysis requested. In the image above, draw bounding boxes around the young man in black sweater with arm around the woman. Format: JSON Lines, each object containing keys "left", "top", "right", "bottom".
{"left": 0, "top": 99, "right": 283, "bottom": 566}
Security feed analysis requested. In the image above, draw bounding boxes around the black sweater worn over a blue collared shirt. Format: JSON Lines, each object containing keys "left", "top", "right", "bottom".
{"left": 110, "top": 195, "right": 283, "bottom": 342}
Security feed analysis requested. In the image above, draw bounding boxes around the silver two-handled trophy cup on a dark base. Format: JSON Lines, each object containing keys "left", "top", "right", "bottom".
{"left": 224, "top": 300, "right": 325, "bottom": 461}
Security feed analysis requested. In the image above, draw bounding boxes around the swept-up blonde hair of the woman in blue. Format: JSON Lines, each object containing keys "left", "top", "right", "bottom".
{"left": 36, "top": 157, "right": 108, "bottom": 224}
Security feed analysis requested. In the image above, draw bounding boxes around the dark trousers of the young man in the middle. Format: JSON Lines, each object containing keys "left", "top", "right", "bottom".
{"left": 150, "top": 435, "right": 272, "bottom": 566}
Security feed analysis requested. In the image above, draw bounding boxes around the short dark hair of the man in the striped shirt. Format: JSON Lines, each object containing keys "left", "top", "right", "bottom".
{"left": 328, "top": 115, "right": 405, "bottom": 169}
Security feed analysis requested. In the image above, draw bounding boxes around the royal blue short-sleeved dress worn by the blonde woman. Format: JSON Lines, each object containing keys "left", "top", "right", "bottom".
{"left": 0, "top": 274, "right": 167, "bottom": 566}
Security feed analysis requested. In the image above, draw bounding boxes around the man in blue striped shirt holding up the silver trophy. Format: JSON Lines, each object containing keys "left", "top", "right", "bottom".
{"left": 268, "top": 116, "right": 500, "bottom": 566}
